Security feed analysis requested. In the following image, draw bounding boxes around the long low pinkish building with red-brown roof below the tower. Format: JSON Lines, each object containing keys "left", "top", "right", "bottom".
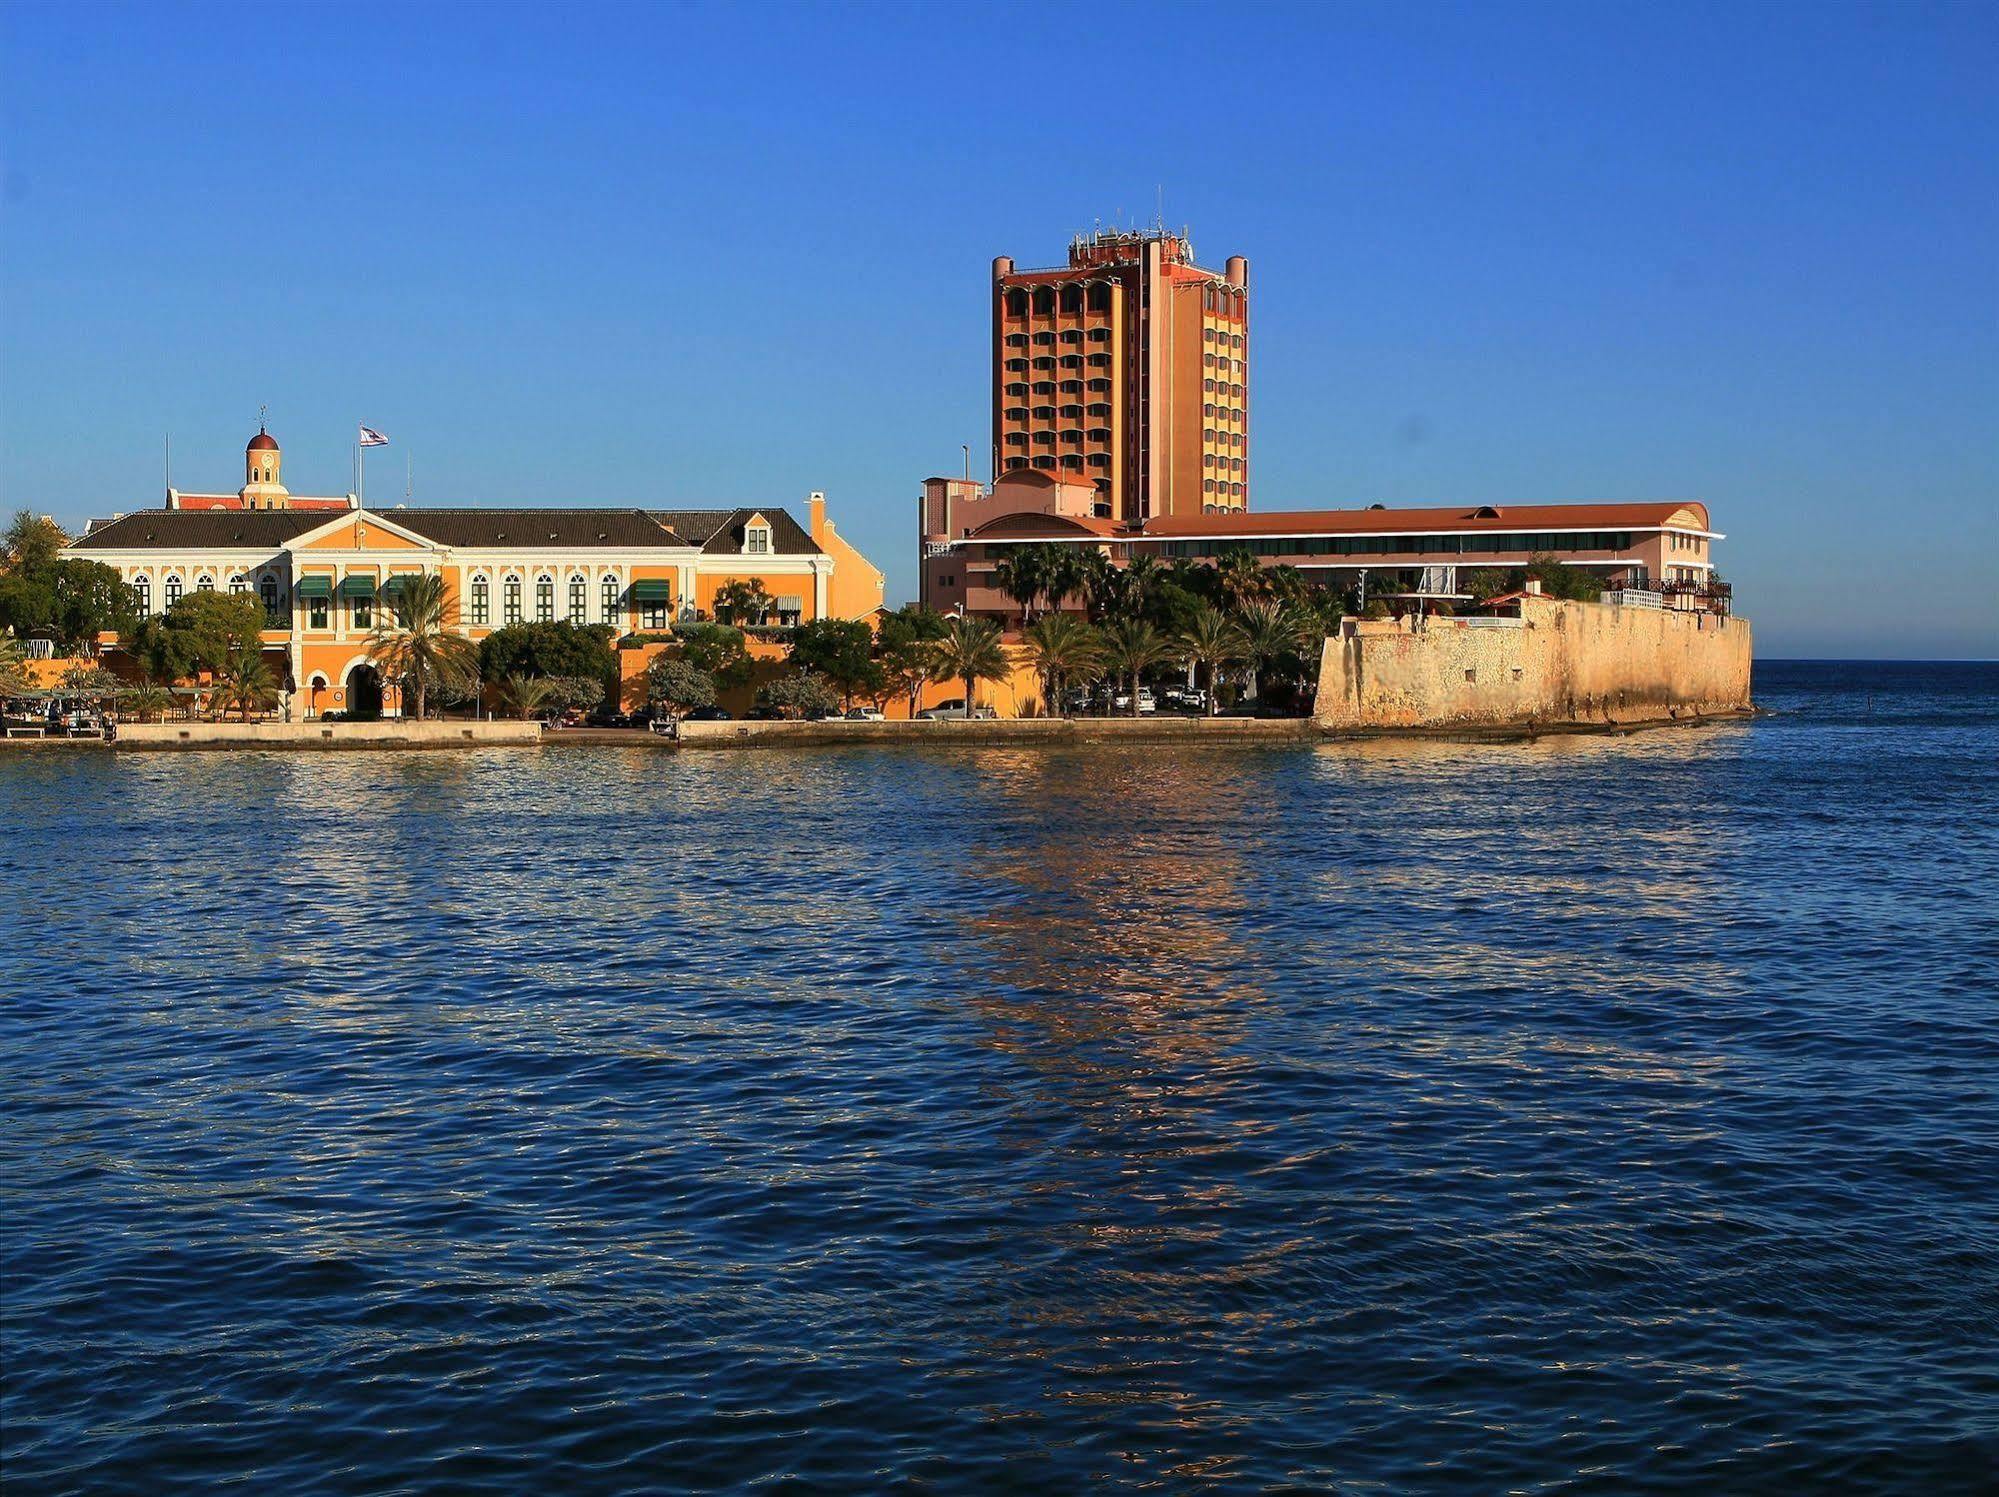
{"left": 920, "top": 470, "right": 1727, "bottom": 616}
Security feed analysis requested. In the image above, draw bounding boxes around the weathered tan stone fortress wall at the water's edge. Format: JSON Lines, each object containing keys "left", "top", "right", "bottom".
{"left": 1315, "top": 598, "right": 1751, "bottom": 730}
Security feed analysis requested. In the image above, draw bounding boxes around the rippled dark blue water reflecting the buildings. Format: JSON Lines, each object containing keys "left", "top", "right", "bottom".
{"left": 0, "top": 666, "right": 1999, "bottom": 1493}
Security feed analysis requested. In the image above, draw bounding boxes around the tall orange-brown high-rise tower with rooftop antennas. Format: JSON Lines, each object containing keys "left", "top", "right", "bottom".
{"left": 994, "top": 230, "right": 1249, "bottom": 522}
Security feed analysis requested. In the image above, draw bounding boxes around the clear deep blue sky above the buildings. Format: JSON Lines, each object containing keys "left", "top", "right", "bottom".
{"left": 0, "top": 0, "right": 1999, "bottom": 658}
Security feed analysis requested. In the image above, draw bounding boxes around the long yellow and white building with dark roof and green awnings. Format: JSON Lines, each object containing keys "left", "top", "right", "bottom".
{"left": 66, "top": 432, "right": 884, "bottom": 716}
